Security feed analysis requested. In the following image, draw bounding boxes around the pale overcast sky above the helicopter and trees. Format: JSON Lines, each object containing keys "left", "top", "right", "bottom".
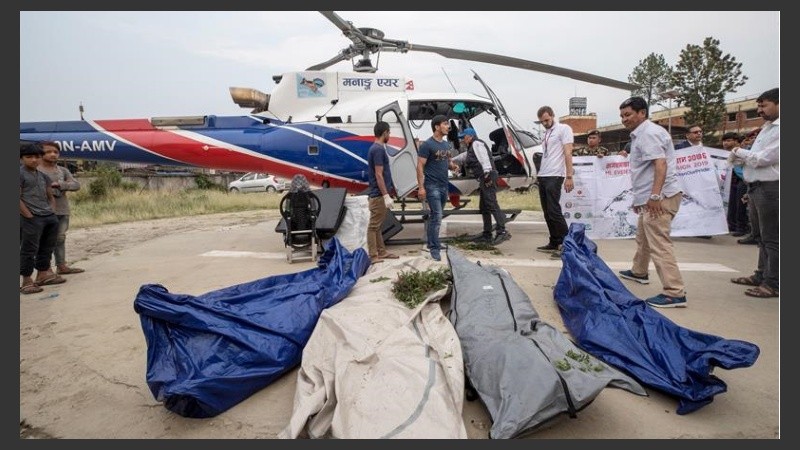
{"left": 19, "top": 11, "right": 780, "bottom": 129}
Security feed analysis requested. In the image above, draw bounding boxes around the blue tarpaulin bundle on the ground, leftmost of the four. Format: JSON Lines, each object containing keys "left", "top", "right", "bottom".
{"left": 133, "top": 238, "right": 370, "bottom": 418}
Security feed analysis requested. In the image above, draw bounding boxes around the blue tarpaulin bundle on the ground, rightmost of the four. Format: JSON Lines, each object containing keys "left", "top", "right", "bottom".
{"left": 553, "top": 223, "right": 760, "bottom": 414}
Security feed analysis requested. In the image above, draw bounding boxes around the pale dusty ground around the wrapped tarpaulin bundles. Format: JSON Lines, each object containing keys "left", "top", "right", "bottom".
{"left": 19, "top": 211, "right": 780, "bottom": 439}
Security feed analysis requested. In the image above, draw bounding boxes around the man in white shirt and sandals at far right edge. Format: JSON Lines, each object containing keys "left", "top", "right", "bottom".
{"left": 730, "top": 88, "right": 781, "bottom": 298}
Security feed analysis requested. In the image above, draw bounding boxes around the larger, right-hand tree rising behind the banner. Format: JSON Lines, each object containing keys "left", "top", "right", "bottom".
{"left": 672, "top": 37, "right": 747, "bottom": 146}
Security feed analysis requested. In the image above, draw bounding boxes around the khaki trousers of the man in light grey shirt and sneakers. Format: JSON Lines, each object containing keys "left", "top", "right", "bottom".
{"left": 631, "top": 192, "right": 686, "bottom": 297}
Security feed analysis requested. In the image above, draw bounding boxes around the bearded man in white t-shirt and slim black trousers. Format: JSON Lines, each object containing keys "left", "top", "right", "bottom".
{"left": 536, "top": 106, "right": 575, "bottom": 255}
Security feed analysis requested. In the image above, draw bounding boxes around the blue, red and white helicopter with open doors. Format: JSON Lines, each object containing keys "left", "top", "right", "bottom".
{"left": 20, "top": 11, "right": 636, "bottom": 206}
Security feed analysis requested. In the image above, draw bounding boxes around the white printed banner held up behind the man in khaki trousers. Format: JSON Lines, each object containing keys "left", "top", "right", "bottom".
{"left": 561, "top": 147, "right": 731, "bottom": 239}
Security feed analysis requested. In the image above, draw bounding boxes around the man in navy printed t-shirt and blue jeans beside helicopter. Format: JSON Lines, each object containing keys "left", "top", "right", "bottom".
{"left": 417, "top": 115, "right": 458, "bottom": 261}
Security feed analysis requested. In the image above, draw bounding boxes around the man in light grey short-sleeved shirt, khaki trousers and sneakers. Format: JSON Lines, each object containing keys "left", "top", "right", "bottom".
{"left": 619, "top": 97, "right": 686, "bottom": 308}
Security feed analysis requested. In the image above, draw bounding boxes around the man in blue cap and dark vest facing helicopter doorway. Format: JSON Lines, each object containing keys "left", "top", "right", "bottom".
{"left": 453, "top": 128, "right": 511, "bottom": 245}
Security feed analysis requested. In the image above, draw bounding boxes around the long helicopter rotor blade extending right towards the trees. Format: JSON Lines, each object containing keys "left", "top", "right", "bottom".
{"left": 408, "top": 44, "right": 639, "bottom": 91}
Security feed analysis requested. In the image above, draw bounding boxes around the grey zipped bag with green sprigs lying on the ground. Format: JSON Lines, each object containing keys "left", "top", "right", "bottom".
{"left": 446, "top": 246, "right": 647, "bottom": 439}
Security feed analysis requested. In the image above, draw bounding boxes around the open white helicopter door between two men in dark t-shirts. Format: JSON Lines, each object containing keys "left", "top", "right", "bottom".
{"left": 376, "top": 101, "right": 417, "bottom": 198}
